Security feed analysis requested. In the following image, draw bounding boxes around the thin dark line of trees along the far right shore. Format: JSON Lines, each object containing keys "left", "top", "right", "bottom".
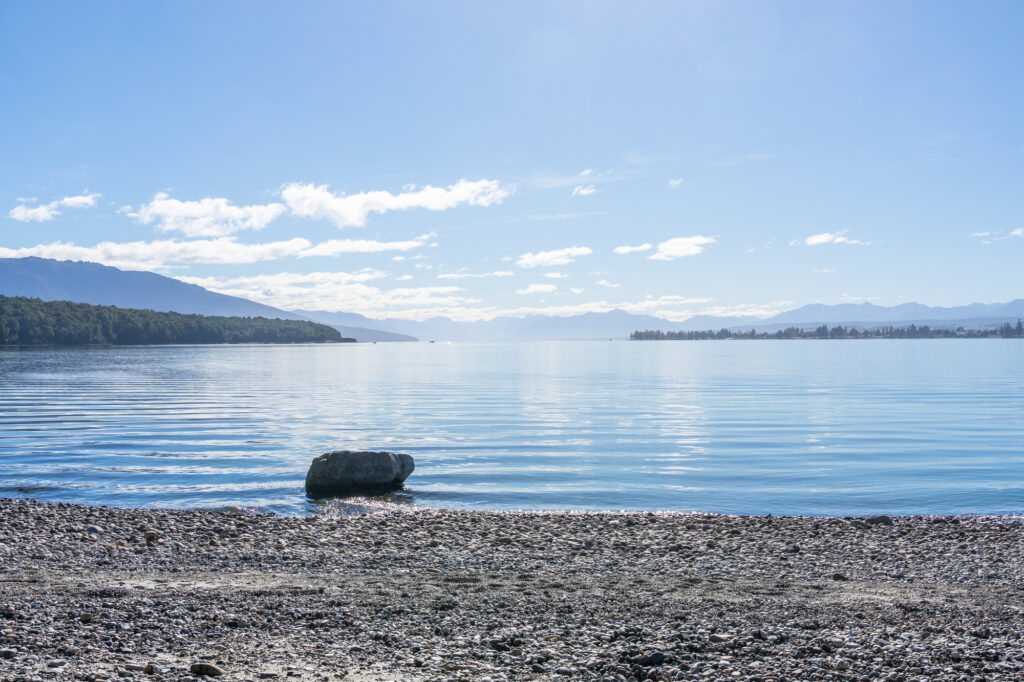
{"left": 630, "top": 319, "right": 1024, "bottom": 341}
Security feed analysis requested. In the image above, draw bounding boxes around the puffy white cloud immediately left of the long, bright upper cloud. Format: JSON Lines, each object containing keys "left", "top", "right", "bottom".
{"left": 128, "top": 191, "right": 286, "bottom": 237}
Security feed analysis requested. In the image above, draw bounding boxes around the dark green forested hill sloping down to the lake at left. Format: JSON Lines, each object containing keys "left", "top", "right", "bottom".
{"left": 0, "top": 296, "right": 354, "bottom": 346}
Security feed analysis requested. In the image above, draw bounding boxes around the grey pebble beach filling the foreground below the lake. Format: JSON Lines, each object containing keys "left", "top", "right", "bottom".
{"left": 0, "top": 493, "right": 1024, "bottom": 681}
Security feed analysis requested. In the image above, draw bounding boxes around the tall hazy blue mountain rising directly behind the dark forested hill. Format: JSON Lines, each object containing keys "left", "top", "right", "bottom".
{"left": 0, "top": 258, "right": 301, "bottom": 319}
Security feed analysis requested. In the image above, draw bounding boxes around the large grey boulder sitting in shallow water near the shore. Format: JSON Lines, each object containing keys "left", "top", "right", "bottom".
{"left": 306, "top": 450, "right": 416, "bottom": 497}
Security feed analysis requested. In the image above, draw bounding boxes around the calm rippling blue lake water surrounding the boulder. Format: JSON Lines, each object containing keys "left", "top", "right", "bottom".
{"left": 0, "top": 339, "right": 1024, "bottom": 515}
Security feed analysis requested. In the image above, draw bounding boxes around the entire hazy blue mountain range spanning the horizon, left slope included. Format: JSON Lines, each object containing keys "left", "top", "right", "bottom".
{"left": 0, "top": 258, "right": 1024, "bottom": 341}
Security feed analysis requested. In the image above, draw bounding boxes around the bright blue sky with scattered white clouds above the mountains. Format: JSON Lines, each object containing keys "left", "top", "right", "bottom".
{"left": 0, "top": 0, "right": 1024, "bottom": 321}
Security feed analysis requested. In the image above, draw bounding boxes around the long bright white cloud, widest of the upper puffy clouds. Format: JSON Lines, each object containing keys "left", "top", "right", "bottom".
{"left": 281, "top": 180, "right": 513, "bottom": 227}
